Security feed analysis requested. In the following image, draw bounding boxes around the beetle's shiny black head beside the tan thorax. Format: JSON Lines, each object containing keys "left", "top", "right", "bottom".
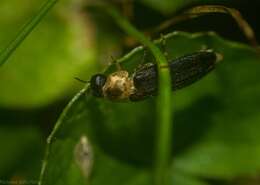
{"left": 90, "top": 74, "right": 107, "bottom": 97}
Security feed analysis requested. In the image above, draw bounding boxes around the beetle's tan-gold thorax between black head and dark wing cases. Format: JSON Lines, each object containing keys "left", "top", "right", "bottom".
{"left": 102, "top": 71, "right": 134, "bottom": 100}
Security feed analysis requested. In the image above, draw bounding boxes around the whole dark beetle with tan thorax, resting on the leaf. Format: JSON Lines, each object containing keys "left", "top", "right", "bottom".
{"left": 90, "top": 50, "right": 221, "bottom": 101}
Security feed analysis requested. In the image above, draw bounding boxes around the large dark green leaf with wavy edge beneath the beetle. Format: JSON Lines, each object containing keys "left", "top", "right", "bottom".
{"left": 38, "top": 32, "right": 260, "bottom": 185}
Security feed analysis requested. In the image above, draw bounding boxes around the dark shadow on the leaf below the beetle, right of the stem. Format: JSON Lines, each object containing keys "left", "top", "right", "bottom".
{"left": 173, "top": 96, "right": 222, "bottom": 155}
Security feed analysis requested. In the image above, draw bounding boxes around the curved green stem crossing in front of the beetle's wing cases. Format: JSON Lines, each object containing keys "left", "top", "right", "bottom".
{"left": 106, "top": 7, "right": 172, "bottom": 185}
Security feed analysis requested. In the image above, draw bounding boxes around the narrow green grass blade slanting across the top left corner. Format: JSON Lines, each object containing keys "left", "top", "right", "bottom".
{"left": 0, "top": 0, "right": 58, "bottom": 66}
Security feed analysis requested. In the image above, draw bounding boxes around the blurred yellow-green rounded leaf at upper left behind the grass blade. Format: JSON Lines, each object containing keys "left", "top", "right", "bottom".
{"left": 0, "top": 0, "right": 95, "bottom": 108}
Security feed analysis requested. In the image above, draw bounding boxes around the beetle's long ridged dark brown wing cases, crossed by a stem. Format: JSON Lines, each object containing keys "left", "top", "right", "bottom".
{"left": 130, "top": 50, "right": 218, "bottom": 101}
